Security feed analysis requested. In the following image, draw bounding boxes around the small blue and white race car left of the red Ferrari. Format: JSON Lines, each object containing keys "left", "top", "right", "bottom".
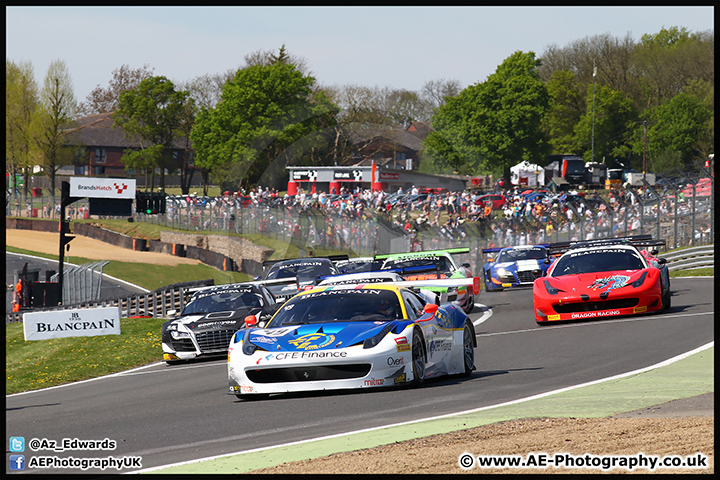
{"left": 483, "top": 244, "right": 549, "bottom": 292}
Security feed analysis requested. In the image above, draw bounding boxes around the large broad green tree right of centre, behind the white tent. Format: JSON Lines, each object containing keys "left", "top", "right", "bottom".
{"left": 425, "top": 52, "right": 550, "bottom": 182}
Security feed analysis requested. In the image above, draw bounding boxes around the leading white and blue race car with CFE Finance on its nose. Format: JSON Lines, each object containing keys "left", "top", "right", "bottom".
{"left": 228, "top": 283, "right": 477, "bottom": 399}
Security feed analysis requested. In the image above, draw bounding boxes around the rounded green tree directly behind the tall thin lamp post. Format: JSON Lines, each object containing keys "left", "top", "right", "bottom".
{"left": 575, "top": 85, "right": 638, "bottom": 167}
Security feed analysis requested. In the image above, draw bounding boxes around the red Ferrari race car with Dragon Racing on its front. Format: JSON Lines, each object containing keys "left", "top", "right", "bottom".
{"left": 533, "top": 235, "right": 671, "bottom": 325}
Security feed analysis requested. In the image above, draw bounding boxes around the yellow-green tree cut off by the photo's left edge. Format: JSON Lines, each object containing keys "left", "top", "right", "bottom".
{"left": 5, "top": 60, "right": 39, "bottom": 196}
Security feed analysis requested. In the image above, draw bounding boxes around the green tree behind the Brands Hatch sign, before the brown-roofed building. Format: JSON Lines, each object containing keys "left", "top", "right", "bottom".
{"left": 113, "top": 76, "right": 192, "bottom": 189}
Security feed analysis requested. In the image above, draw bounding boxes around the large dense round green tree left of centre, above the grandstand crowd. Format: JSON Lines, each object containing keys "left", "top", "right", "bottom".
{"left": 190, "top": 61, "right": 337, "bottom": 189}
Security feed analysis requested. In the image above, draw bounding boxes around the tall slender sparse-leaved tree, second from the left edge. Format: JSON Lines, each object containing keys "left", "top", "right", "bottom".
{"left": 33, "top": 60, "right": 77, "bottom": 200}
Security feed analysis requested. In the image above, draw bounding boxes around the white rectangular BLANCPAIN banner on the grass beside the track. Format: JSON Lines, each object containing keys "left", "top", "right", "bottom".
{"left": 23, "top": 307, "right": 120, "bottom": 340}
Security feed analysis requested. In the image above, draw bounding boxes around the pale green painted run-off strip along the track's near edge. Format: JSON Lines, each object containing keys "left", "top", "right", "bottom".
{"left": 134, "top": 342, "right": 715, "bottom": 474}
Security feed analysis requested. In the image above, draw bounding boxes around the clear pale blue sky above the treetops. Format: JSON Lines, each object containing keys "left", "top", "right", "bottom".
{"left": 5, "top": 6, "right": 714, "bottom": 102}
